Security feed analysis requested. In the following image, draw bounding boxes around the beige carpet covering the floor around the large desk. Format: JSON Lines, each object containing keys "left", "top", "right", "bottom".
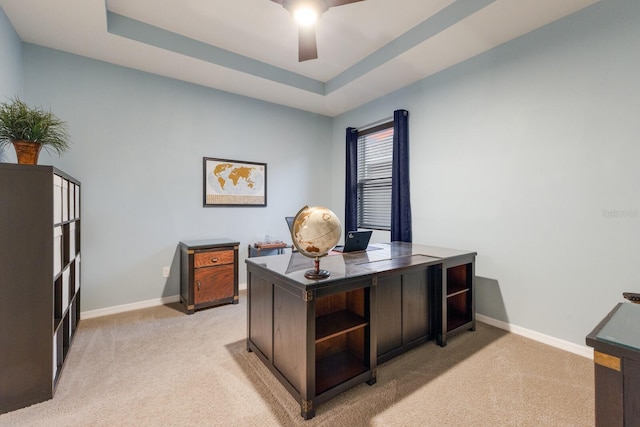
{"left": 0, "top": 293, "right": 594, "bottom": 427}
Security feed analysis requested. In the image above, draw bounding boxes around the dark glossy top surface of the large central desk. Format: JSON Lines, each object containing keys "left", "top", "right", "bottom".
{"left": 245, "top": 242, "right": 476, "bottom": 290}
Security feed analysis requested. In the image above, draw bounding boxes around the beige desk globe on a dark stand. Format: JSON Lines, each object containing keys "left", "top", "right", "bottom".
{"left": 291, "top": 206, "right": 342, "bottom": 279}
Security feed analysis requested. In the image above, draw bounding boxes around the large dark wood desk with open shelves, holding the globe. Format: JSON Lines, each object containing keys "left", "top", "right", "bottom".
{"left": 246, "top": 242, "right": 476, "bottom": 419}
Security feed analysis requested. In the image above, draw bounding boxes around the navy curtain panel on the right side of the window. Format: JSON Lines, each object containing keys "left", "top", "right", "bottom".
{"left": 391, "top": 110, "right": 412, "bottom": 242}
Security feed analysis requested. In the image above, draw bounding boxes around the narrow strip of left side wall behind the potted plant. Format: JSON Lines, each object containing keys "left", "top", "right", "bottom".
{"left": 0, "top": 8, "right": 22, "bottom": 163}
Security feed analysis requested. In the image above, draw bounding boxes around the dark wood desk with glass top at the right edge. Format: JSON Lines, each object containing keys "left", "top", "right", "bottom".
{"left": 586, "top": 303, "right": 640, "bottom": 427}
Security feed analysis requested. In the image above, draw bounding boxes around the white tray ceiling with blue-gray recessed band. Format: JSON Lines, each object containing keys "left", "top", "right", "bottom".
{"left": 0, "top": 0, "right": 600, "bottom": 116}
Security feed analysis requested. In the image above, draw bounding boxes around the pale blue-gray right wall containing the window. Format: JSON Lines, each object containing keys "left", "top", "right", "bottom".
{"left": 333, "top": 0, "right": 640, "bottom": 344}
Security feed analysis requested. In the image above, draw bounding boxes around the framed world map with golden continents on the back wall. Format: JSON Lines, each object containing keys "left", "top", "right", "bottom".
{"left": 202, "top": 157, "right": 267, "bottom": 207}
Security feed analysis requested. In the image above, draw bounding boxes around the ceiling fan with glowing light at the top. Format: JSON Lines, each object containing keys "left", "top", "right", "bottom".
{"left": 271, "top": 0, "right": 364, "bottom": 62}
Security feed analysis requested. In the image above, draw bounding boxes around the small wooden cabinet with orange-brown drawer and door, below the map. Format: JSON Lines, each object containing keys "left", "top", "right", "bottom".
{"left": 180, "top": 239, "right": 240, "bottom": 314}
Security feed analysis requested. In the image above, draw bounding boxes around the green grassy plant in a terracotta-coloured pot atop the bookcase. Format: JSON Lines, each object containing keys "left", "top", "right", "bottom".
{"left": 0, "top": 97, "right": 70, "bottom": 165}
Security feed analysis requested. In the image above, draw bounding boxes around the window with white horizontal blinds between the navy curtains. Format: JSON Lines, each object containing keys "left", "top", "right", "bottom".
{"left": 357, "top": 121, "right": 393, "bottom": 231}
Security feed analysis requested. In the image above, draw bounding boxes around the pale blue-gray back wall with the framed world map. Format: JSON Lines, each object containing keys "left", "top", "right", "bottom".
{"left": 24, "top": 44, "right": 331, "bottom": 311}
